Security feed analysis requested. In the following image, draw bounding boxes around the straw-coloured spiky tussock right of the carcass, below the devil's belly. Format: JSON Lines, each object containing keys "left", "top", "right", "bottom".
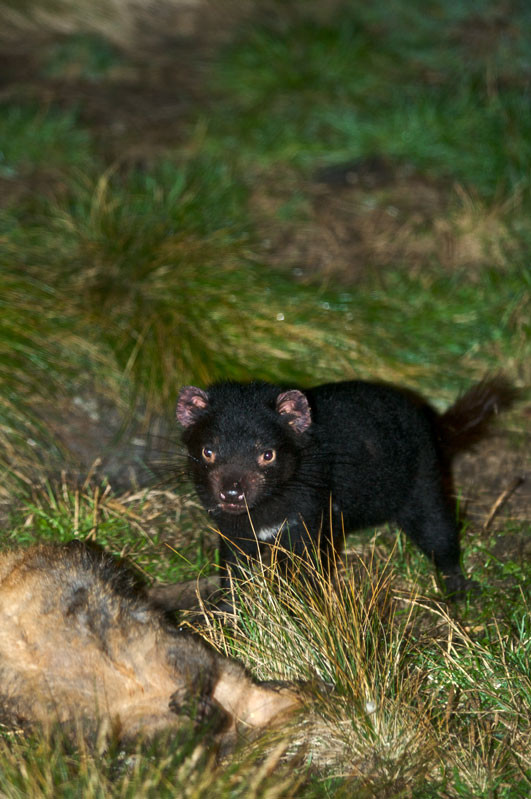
{"left": 201, "top": 553, "right": 440, "bottom": 796}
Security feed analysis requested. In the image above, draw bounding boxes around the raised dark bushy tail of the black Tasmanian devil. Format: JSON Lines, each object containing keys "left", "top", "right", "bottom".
{"left": 437, "top": 375, "right": 520, "bottom": 455}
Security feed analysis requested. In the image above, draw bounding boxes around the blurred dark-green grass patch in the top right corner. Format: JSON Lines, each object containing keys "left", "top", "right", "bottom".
{"left": 213, "top": 3, "right": 531, "bottom": 200}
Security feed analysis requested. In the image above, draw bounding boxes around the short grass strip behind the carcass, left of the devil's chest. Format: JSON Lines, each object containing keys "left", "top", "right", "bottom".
{"left": 2, "top": 480, "right": 213, "bottom": 583}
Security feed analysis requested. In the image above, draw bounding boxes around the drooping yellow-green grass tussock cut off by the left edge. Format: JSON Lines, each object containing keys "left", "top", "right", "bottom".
{"left": 0, "top": 260, "right": 131, "bottom": 501}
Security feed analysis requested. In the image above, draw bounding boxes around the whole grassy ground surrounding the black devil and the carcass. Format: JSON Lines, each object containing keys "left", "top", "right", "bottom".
{"left": 0, "top": 0, "right": 531, "bottom": 799}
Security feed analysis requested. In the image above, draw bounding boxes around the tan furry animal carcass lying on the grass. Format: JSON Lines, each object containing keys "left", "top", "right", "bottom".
{"left": 0, "top": 541, "right": 297, "bottom": 739}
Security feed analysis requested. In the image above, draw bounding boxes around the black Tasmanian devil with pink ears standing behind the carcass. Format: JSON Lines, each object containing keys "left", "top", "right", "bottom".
{"left": 177, "top": 376, "right": 516, "bottom": 594}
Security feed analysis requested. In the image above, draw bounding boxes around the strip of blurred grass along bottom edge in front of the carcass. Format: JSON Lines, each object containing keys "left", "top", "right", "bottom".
{"left": 0, "top": 731, "right": 308, "bottom": 799}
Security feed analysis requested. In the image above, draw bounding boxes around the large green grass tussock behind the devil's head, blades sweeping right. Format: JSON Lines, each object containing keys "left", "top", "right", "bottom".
{"left": 25, "top": 160, "right": 450, "bottom": 411}
